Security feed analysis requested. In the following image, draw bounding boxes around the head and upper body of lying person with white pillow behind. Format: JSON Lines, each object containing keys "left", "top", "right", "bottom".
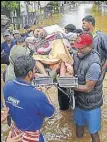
{"left": 26, "top": 25, "right": 76, "bottom": 55}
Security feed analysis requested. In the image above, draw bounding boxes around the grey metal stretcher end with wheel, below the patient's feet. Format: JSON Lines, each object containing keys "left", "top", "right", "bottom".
{"left": 33, "top": 76, "right": 78, "bottom": 109}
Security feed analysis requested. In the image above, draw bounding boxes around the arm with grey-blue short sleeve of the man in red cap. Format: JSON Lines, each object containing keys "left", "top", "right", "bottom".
{"left": 74, "top": 63, "right": 101, "bottom": 93}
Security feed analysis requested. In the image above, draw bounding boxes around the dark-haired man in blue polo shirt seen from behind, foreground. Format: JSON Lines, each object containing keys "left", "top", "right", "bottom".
{"left": 3, "top": 56, "right": 55, "bottom": 142}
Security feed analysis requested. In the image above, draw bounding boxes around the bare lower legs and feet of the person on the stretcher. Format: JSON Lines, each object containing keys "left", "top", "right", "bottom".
{"left": 35, "top": 58, "right": 74, "bottom": 78}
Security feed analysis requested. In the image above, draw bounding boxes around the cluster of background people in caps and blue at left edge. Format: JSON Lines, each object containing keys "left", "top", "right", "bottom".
{"left": 1, "top": 25, "right": 32, "bottom": 65}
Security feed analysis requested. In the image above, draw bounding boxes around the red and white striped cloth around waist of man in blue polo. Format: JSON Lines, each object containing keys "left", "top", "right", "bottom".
{"left": 12, "top": 125, "right": 40, "bottom": 142}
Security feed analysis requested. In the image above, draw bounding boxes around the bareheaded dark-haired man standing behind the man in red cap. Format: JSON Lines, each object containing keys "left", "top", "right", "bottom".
{"left": 82, "top": 15, "right": 107, "bottom": 78}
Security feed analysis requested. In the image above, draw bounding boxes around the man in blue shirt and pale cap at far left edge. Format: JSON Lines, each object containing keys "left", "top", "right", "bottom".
{"left": 1, "top": 31, "right": 15, "bottom": 65}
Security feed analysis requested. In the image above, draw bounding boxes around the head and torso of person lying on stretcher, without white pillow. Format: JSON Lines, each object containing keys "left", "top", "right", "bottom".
{"left": 25, "top": 28, "right": 55, "bottom": 54}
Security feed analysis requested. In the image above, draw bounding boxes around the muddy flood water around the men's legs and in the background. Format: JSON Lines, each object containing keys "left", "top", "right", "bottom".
{"left": 3, "top": 4, "right": 107, "bottom": 142}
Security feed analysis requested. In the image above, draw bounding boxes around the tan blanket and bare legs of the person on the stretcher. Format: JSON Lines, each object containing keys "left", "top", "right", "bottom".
{"left": 33, "top": 39, "right": 73, "bottom": 79}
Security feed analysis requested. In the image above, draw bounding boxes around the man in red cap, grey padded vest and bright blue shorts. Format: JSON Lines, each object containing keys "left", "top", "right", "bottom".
{"left": 73, "top": 33, "right": 103, "bottom": 142}
